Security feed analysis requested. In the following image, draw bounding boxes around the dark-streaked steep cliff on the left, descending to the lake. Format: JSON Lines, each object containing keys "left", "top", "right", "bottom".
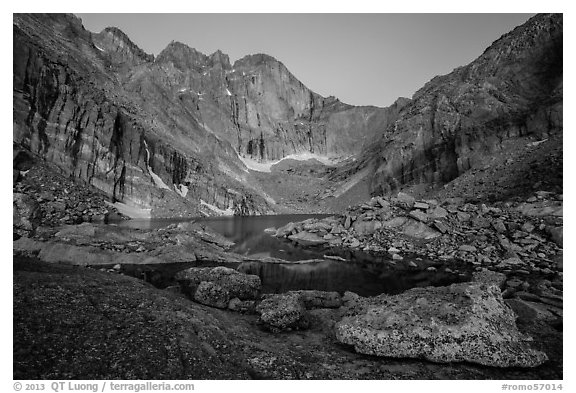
{"left": 13, "top": 15, "right": 273, "bottom": 216}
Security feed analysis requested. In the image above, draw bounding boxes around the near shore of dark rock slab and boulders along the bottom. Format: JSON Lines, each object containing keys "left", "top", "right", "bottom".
{"left": 13, "top": 254, "right": 562, "bottom": 379}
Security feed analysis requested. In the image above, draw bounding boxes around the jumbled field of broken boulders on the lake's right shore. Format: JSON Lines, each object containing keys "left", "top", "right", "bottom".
{"left": 270, "top": 191, "right": 563, "bottom": 306}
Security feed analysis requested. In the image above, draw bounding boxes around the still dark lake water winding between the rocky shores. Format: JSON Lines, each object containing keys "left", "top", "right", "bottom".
{"left": 112, "top": 214, "right": 470, "bottom": 296}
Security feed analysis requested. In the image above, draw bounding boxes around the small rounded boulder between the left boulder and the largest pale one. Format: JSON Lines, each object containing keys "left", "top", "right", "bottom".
{"left": 256, "top": 293, "right": 308, "bottom": 333}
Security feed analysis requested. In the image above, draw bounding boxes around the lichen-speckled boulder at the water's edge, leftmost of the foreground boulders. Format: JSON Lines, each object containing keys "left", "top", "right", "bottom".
{"left": 176, "top": 266, "right": 262, "bottom": 300}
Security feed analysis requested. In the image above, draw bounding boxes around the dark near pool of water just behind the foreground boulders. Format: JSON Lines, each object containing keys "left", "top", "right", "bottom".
{"left": 238, "top": 261, "right": 464, "bottom": 296}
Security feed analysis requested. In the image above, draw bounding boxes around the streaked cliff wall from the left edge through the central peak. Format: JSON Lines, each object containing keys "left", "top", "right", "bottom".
{"left": 13, "top": 14, "right": 399, "bottom": 217}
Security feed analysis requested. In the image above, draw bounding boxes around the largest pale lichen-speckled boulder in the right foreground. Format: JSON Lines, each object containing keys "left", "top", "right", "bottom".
{"left": 335, "top": 283, "right": 547, "bottom": 367}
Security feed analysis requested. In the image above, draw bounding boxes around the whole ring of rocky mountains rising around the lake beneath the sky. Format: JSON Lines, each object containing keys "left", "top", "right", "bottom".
{"left": 14, "top": 14, "right": 563, "bottom": 217}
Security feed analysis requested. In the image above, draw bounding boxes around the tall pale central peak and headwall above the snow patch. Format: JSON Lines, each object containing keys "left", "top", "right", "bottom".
{"left": 148, "top": 46, "right": 396, "bottom": 162}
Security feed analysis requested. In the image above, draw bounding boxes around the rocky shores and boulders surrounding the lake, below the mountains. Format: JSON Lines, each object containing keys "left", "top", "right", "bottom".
{"left": 14, "top": 188, "right": 563, "bottom": 379}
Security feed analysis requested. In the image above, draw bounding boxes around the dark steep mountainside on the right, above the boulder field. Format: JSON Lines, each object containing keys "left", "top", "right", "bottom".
{"left": 340, "top": 14, "right": 562, "bottom": 194}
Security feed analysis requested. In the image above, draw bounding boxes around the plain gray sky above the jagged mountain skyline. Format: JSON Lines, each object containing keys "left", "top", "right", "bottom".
{"left": 77, "top": 14, "right": 532, "bottom": 106}
